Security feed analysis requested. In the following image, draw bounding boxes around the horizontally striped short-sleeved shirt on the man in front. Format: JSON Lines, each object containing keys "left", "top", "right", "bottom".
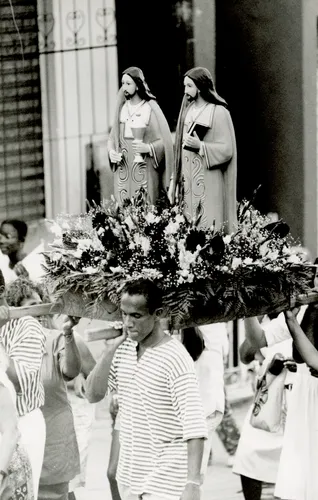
{"left": 108, "top": 339, "right": 207, "bottom": 498}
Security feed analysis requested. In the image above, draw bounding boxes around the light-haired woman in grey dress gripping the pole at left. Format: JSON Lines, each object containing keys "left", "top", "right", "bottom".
{"left": 7, "top": 278, "right": 81, "bottom": 500}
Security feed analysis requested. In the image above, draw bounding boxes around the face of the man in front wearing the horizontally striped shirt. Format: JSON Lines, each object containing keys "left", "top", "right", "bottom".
{"left": 120, "top": 293, "right": 158, "bottom": 342}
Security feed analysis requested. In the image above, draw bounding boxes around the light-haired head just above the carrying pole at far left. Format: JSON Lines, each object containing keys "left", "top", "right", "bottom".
{"left": 5, "top": 278, "right": 49, "bottom": 307}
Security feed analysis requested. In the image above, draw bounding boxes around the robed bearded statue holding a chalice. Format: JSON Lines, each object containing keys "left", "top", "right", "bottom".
{"left": 108, "top": 67, "right": 174, "bottom": 204}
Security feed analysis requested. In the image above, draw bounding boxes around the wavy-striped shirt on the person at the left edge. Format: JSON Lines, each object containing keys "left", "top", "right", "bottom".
{"left": 0, "top": 316, "right": 45, "bottom": 416}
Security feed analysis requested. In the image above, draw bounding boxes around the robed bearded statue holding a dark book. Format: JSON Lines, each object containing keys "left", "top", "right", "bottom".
{"left": 175, "top": 67, "right": 237, "bottom": 232}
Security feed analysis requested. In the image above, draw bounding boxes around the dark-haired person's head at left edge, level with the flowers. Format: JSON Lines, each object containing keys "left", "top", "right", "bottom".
{"left": 0, "top": 219, "right": 28, "bottom": 255}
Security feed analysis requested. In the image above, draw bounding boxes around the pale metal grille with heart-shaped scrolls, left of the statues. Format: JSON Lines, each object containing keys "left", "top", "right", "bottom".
{"left": 38, "top": 0, "right": 118, "bottom": 215}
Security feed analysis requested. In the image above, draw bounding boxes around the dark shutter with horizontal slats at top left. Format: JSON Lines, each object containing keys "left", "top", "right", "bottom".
{"left": 0, "top": 0, "right": 45, "bottom": 220}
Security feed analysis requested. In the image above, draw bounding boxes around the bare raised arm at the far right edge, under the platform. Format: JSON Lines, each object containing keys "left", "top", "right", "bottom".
{"left": 285, "top": 310, "right": 318, "bottom": 371}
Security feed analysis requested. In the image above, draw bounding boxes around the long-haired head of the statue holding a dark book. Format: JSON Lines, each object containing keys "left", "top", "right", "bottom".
{"left": 183, "top": 67, "right": 227, "bottom": 106}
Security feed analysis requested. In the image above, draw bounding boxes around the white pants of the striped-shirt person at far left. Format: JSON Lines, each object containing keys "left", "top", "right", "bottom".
{"left": 19, "top": 408, "right": 46, "bottom": 500}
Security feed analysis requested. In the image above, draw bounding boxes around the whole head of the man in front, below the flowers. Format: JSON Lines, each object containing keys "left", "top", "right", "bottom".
{"left": 120, "top": 279, "right": 162, "bottom": 342}
